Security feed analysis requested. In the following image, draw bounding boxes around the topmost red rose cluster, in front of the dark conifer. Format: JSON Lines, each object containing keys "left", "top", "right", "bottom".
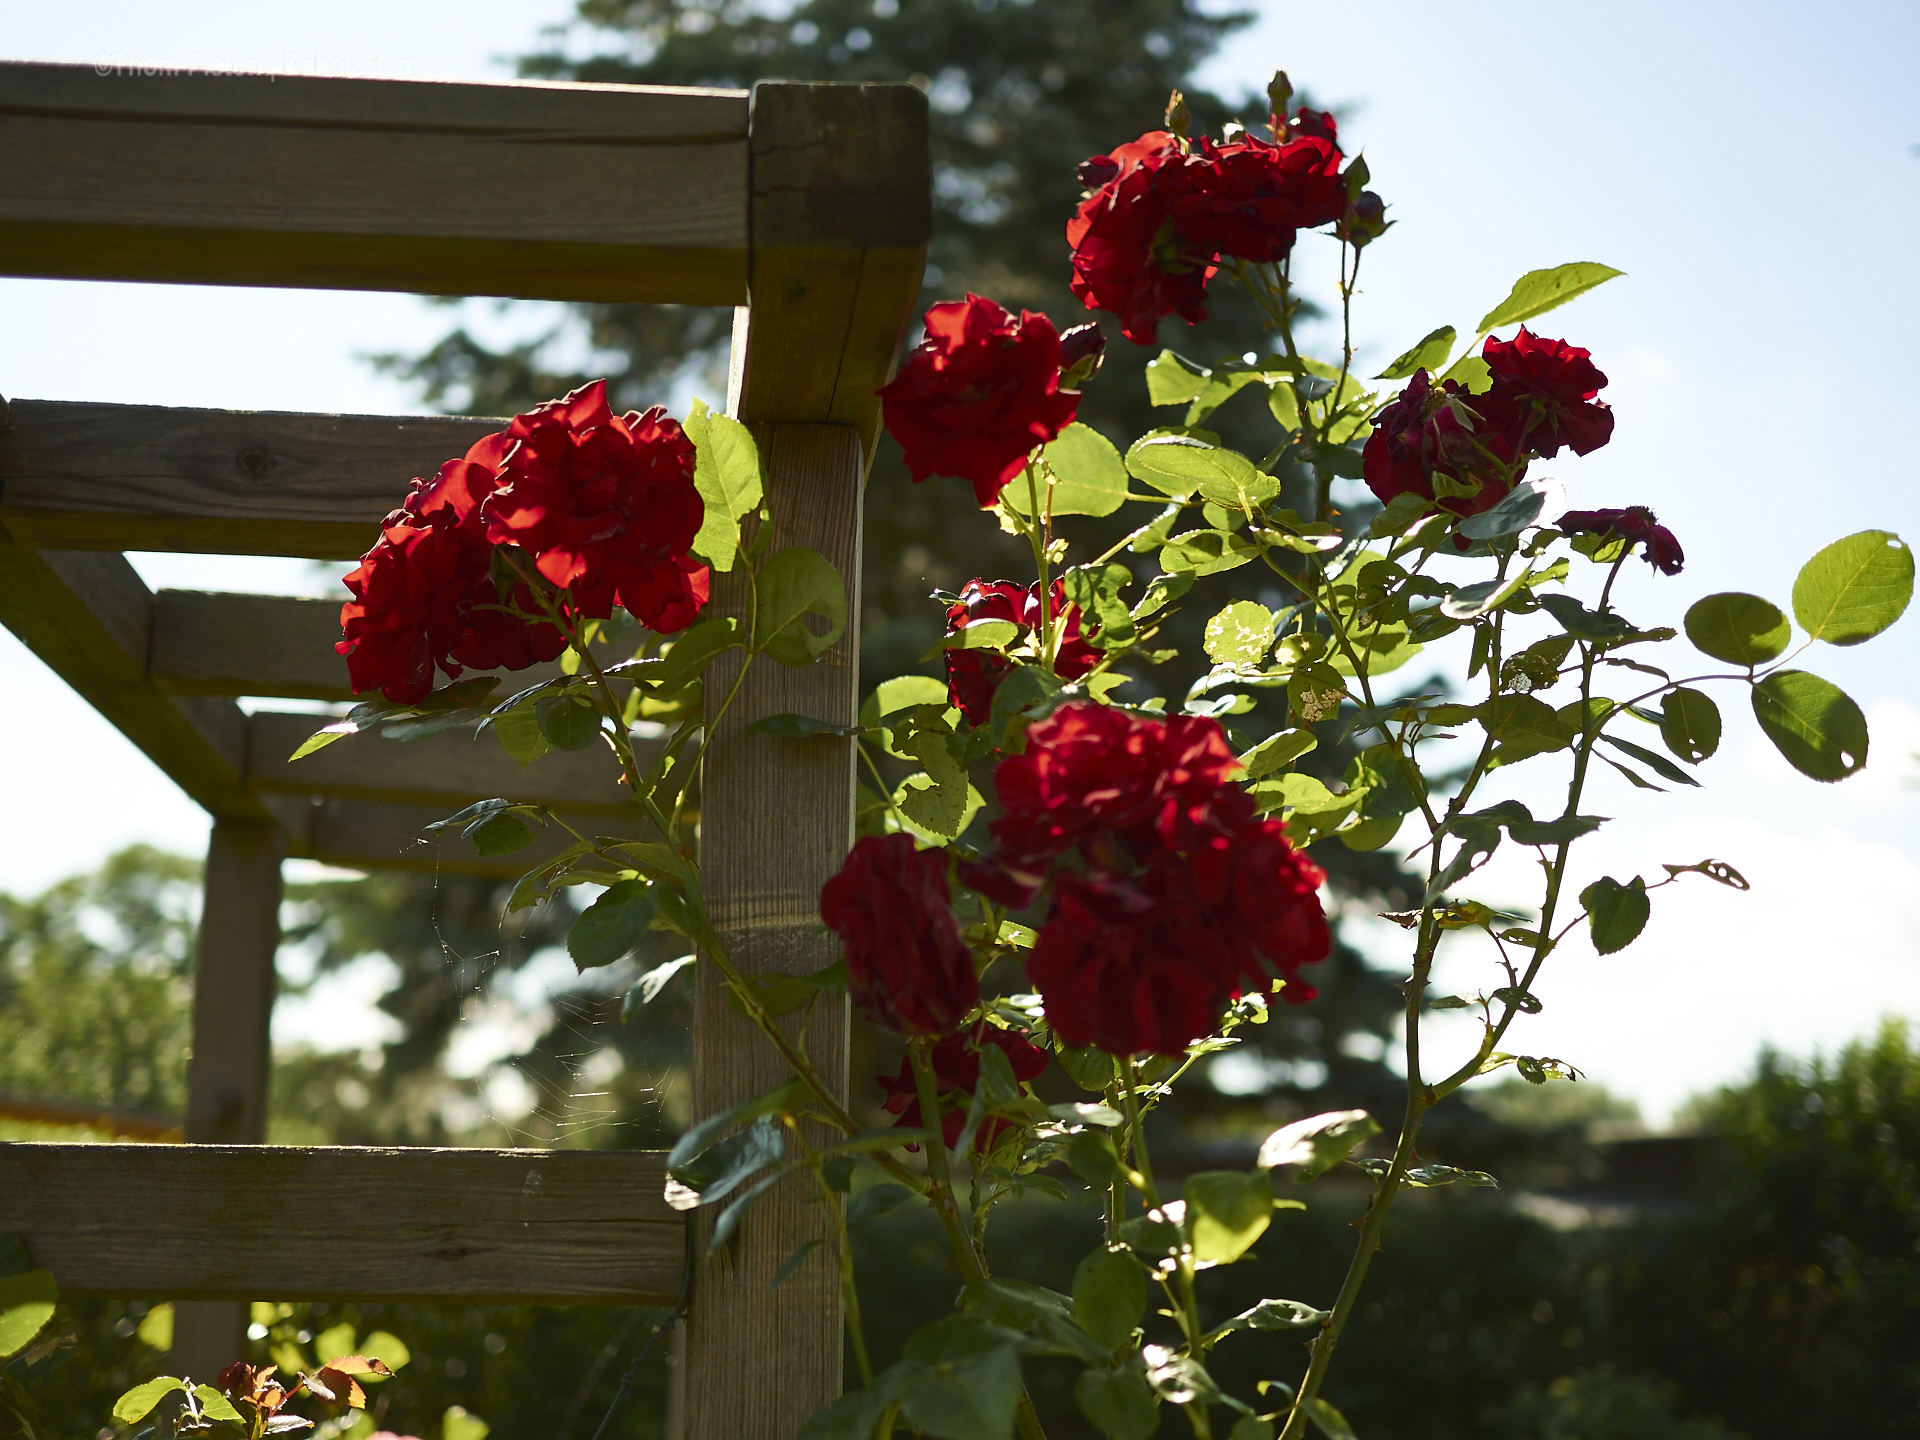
{"left": 1068, "top": 109, "right": 1384, "bottom": 346}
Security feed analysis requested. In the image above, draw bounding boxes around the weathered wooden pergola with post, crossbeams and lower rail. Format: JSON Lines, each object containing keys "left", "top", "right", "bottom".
{"left": 0, "top": 63, "right": 931, "bottom": 1440}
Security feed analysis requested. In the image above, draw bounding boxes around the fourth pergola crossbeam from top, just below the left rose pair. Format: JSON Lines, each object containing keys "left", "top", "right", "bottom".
{"left": 246, "top": 710, "right": 645, "bottom": 816}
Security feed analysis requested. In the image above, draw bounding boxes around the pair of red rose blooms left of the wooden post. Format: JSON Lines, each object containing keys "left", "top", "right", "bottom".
{"left": 334, "top": 380, "right": 707, "bottom": 705}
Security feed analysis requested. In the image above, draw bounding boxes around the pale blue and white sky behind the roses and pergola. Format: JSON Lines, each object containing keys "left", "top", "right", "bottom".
{"left": 0, "top": 0, "right": 1920, "bottom": 1114}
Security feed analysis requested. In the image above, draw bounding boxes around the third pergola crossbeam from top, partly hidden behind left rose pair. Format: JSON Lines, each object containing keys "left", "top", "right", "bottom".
{"left": 146, "top": 589, "right": 634, "bottom": 701}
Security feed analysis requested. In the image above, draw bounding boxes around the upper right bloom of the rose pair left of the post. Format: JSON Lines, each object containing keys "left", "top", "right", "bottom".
{"left": 486, "top": 380, "right": 708, "bottom": 632}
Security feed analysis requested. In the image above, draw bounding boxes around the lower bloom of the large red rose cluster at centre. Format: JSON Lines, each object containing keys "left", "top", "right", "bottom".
{"left": 1027, "top": 833, "right": 1332, "bottom": 1056}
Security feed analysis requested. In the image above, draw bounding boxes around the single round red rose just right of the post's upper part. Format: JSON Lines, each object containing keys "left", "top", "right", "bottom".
{"left": 879, "top": 294, "right": 1079, "bottom": 509}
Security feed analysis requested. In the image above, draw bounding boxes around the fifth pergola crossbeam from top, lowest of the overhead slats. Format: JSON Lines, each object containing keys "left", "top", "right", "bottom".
{"left": 271, "top": 789, "right": 659, "bottom": 879}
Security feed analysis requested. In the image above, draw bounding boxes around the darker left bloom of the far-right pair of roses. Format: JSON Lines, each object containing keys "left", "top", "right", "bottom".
{"left": 1361, "top": 371, "right": 1526, "bottom": 515}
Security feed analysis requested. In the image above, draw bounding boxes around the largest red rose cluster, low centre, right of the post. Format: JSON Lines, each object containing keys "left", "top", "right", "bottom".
{"left": 962, "top": 703, "right": 1332, "bottom": 1054}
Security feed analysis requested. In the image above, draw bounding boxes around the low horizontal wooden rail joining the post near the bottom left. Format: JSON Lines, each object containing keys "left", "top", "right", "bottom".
{"left": 0, "top": 1144, "right": 685, "bottom": 1306}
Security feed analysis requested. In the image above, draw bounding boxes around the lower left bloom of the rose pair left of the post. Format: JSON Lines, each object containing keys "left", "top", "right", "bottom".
{"left": 334, "top": 434, "right": 566, "bottom": 705}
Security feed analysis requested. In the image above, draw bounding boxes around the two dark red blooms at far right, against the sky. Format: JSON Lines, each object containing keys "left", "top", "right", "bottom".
{"left": 1361, "top": 324, "right": 1613, "bottom": 516}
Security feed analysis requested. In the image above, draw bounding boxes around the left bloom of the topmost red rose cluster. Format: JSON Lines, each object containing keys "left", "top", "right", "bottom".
{"left": 1068, "top": 131, "right": 1217, "bottom": 346}
